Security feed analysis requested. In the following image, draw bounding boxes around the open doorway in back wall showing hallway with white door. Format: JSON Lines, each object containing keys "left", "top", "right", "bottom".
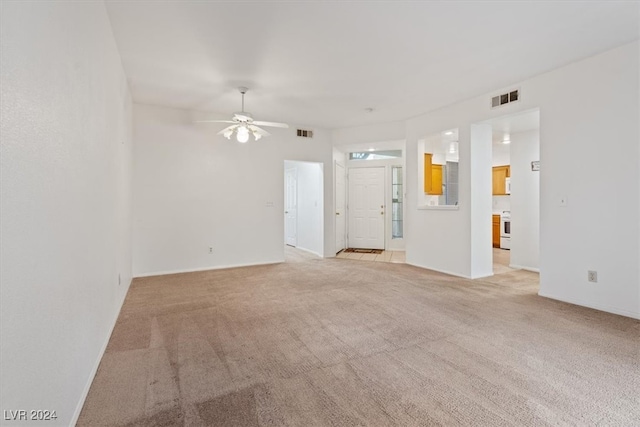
{"left": 284, "top": 160, "right": 324, "bottom": 256}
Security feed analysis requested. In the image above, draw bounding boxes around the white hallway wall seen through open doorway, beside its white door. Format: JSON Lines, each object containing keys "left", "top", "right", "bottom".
{"left": 284, "top": 161, "right": 324, "bottom": 256}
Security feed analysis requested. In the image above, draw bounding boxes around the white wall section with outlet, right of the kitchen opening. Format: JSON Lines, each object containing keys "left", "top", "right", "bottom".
{"left": 536, "top": 42, "right": 640, "bottom": 318}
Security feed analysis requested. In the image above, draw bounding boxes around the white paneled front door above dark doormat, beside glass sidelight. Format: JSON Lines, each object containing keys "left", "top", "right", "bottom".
{"left": 349, "top": 167, "right": 385, "bottom": 249}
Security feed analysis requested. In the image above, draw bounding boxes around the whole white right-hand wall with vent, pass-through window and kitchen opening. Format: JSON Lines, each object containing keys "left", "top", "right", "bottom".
{"left": 406, "top": 42, "right": 640, "bottom": 317}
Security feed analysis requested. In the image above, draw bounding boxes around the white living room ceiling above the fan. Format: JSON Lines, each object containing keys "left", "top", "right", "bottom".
{"left": 107, "top": 0, "right": 640, "bottom": 128}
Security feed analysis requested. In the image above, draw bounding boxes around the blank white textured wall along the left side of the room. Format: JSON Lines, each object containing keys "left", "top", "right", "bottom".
{"left": 0, "top": 2, "right": 131, "bottom": 425}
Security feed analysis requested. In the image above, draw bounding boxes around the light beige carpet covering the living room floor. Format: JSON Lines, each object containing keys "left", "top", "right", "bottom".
{"left": 78, "top": 250, "right": 640, "bottom": 426}
